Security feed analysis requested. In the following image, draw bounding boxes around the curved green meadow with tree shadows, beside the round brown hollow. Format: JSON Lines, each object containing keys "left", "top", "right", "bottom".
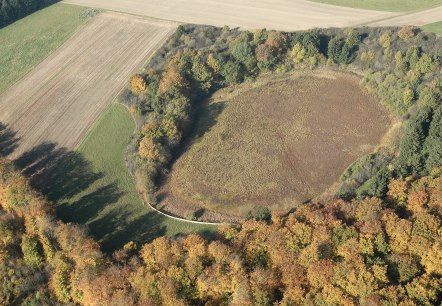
{"left": 49, "top": 104, "right": 216, "bottom": 251}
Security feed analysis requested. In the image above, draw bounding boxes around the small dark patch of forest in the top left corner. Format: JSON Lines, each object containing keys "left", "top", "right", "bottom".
{"left": 0, "top": 0, "right": 56, "bottom": 28}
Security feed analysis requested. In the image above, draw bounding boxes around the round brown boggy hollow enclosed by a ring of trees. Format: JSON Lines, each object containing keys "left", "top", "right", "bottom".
{"left": 159, "top": 72, "right": 390, "bottom": 221}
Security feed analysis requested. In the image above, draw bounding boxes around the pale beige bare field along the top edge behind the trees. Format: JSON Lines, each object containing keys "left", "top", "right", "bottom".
{"left": 63, "top": 0, "right": 398, "bottom": 31}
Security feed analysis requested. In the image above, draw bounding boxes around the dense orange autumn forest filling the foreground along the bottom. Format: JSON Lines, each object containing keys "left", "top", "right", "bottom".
{"left": 0, "top": 160, "right": 442, "bottom": 305}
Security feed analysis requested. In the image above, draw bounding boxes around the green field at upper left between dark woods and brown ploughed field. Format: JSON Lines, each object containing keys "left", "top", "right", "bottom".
{"left": 0, "top": 4, "right": 90, "bottom": 93}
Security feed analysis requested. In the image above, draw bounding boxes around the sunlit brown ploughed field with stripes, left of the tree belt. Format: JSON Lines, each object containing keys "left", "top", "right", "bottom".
{"left": 0, "top": 13, "right": 176, "bottom": 158}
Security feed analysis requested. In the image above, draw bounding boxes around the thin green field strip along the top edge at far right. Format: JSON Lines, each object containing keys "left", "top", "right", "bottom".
{"left": 313, "top": 0, "right": 442, "bottom": 12}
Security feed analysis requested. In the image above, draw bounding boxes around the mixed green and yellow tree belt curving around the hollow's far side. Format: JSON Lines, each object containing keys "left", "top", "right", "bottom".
{"left": 120, "top": 25, "right": 442, "bottom": 218}
